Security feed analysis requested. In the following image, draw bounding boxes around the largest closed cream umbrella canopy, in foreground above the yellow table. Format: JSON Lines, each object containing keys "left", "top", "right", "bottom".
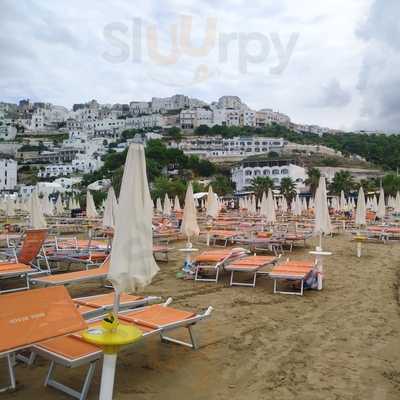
{"left": 108, "top": 143, "right": 159, "bottom": 293}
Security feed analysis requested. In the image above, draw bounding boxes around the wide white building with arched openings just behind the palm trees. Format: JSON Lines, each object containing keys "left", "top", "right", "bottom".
{"left": 231, "top": 160, "right": 307, "bottom": 192}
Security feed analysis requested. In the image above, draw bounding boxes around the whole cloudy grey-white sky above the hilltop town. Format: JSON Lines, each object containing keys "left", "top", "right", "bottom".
{"left": 0, "top": 0, "right": 400, "bottom": 131}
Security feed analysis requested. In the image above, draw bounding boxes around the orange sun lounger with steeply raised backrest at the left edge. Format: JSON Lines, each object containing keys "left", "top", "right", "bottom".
{"left": 0, "top": 229, "right": 49, "bottom": 293}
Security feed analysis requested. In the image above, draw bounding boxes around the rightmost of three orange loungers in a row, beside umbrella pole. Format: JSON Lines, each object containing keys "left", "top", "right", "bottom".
{"left": 269, "top": 261, "right": 315, "bottom": 296}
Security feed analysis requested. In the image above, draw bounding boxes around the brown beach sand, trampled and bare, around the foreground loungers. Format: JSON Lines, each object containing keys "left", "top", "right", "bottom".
{"left": 0, "top": 235, "right": 400, "bottom": 400}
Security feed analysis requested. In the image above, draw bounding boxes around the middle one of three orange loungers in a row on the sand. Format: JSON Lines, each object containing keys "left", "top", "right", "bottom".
{"left": 224, "top": 255, "right": 279, "bottom": 287}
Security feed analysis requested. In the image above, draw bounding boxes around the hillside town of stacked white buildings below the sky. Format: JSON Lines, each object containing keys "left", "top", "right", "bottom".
{"left": 0, "top": 94, "right": 380, "bottom": 200}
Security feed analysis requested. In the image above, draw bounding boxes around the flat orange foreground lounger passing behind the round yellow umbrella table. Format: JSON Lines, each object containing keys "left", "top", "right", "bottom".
{"left": 32, "top": 299, "right": 212, "bottom": 400}
